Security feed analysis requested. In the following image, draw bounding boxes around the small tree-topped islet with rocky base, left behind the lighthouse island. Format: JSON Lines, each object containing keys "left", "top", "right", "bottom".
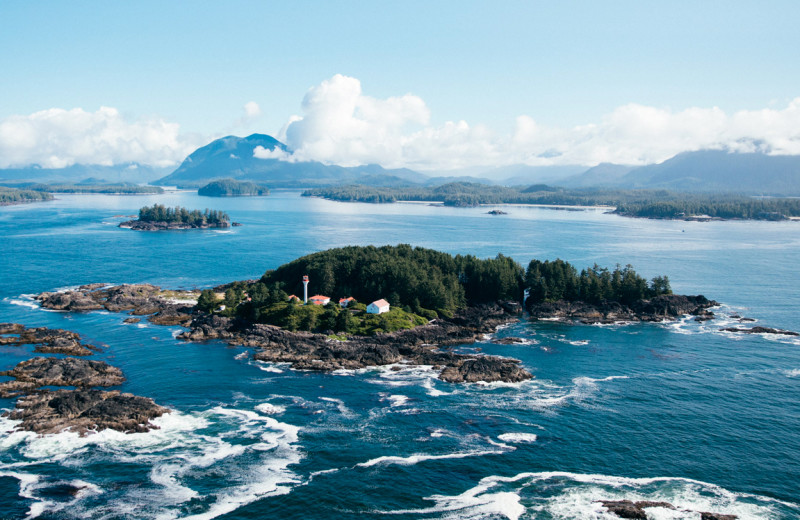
{"left": 119, "top": 204, "right": 240, "bottom": 231}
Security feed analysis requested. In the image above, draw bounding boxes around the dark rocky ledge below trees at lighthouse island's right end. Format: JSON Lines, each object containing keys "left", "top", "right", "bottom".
{"left": 527, "top": 294, "right": 718, "bottom": 324}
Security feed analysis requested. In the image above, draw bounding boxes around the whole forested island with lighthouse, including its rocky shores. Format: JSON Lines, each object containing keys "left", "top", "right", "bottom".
{"left": 36, "top": 244, "right": 716, "bottom": 382}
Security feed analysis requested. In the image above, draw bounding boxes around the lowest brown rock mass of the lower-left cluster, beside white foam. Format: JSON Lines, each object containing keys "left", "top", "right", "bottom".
{"left": 5, "top": 389, "right": 169, "bottom": 435}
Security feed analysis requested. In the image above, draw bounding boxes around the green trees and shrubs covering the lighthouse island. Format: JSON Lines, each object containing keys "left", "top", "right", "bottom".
{"left": 198, "top": 244, "right": 671, "bottom": 334}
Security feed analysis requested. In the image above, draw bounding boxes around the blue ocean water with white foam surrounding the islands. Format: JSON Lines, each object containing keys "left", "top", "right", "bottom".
{"left": 0, "top": 191, "right": 800, "bottom": 519}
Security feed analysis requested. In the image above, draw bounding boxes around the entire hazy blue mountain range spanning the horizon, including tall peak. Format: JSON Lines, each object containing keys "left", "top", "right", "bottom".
{"left": 0, "top": 134, "right": 800, "bottom": 196}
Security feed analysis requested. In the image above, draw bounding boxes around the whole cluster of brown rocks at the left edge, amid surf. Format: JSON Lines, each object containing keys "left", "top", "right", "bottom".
{"left": 0, "top": 323, "right": 170, "bottom": 435}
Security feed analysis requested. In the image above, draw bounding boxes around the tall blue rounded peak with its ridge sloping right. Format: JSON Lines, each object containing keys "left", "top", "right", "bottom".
{"left": 154, "top": 134, "right": 434, "bottom": 188}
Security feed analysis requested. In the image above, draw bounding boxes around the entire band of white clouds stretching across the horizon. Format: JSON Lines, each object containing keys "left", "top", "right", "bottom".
{"left": 0, "top": 74, "right": 800, "bottom": 171}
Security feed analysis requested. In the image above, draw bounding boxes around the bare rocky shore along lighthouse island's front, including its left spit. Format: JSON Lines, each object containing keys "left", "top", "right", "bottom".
{"left": 35, "top": 284, "right": 533, "bottom": 383}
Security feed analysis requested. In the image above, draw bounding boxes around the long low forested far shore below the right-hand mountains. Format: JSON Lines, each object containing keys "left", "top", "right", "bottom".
{"left": 303, "top": 182, "right": 800, "bottom": 220}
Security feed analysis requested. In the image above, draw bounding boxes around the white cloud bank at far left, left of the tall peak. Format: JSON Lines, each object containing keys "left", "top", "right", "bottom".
{"left": 0, "top": 107, "right": 197, "bottom": 168}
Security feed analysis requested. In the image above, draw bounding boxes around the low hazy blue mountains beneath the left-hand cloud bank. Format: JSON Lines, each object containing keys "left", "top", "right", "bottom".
{"left": 0, "top": 163, "right": 170, "bottom": 184}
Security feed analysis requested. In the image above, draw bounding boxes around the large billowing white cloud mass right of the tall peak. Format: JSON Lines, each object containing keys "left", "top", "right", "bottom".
{"left": 273, "top": 75, "right": 800, "bottom": 170}
